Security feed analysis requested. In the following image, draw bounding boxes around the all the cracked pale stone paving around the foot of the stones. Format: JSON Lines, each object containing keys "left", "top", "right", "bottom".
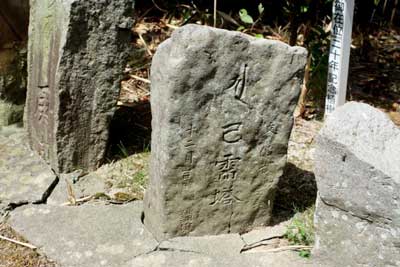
{"left": 0, "top": 126, "right": 316, "bottom": 267}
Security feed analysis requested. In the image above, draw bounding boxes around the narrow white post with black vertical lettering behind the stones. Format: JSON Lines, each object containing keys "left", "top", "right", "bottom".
{"left": 325, "top": 0, "right": 354, "bottom": 116}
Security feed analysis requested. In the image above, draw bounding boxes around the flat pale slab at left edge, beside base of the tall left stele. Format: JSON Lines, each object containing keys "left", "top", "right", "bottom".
{"left": 0, "top": 125, "right": 57, "bottom": 211}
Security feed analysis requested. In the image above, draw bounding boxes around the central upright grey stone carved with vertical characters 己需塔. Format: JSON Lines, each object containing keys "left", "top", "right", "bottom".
{"left": 145, "top": 25, "right": 307, "bottom": 239}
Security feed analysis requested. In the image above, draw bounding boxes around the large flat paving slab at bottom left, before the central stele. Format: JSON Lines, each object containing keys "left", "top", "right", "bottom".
{"left": 9, "top": 202, "right": 158, "bottom": 267}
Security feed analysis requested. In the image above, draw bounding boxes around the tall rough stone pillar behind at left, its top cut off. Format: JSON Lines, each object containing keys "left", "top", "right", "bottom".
{"left": 24, "top": 0, "right": 134, "bottom": 172}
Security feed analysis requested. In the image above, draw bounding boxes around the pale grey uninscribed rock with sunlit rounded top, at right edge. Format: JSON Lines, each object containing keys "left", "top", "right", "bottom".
{"left": 314, "top": 102, "right": 400, "bottom": 266}
